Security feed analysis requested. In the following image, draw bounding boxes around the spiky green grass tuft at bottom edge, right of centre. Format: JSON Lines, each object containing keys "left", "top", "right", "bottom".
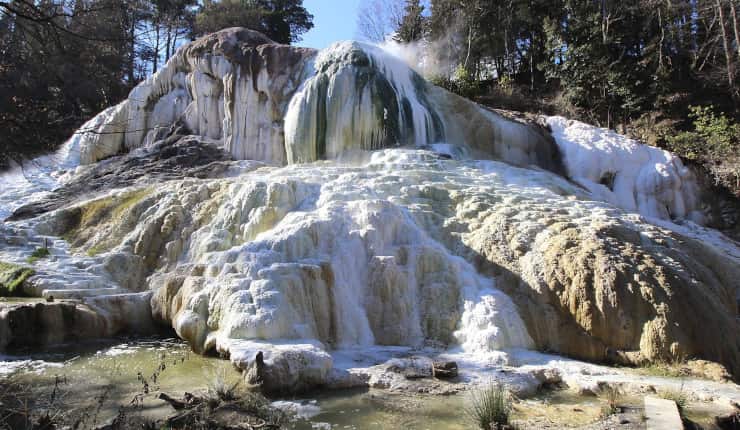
{"left": 467, "top": 382, "right": 512, "bottom": 430}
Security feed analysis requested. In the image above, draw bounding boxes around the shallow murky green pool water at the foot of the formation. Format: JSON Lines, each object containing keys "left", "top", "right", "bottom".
{"left": 0, "top": 339, "right": 600, "bottom": 430}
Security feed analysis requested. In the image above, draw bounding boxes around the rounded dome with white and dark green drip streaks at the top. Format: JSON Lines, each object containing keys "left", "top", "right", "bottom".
{"left": 285, "top": 42, "right": 444, "bottom": 163}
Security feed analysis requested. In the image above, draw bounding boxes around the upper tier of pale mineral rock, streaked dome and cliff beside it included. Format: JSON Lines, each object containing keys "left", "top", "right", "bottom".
{"left": 66, "top": 28, "right": 560, "bottom": 174}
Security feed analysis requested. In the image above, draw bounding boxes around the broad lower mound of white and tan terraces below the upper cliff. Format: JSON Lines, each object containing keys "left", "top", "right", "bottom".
{"left": 20, "top": 150, "right": 740, "bottom": 391}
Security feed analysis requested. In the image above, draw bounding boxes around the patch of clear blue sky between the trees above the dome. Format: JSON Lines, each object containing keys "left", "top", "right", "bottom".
{"left": 296, "top": 0, "right": 362, "bottom": 49}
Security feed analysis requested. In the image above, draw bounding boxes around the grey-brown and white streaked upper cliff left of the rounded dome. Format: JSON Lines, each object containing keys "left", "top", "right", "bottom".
{"left": 66, "top": 28, "right": 316, "bottom": 164}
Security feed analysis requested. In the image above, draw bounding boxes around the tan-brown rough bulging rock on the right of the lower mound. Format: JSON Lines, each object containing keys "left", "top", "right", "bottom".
{"left": 463, "top": 203, "right": 740, "bottom": 375}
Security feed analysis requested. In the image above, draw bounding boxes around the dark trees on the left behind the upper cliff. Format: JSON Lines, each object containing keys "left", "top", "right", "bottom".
{"left": 0, "top": 0, "right": 313, "bottom": 168}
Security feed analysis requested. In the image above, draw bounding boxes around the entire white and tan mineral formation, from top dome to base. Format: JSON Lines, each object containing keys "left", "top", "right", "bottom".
{"left": 0, "top": 29, "right": 740, "bottom": 392}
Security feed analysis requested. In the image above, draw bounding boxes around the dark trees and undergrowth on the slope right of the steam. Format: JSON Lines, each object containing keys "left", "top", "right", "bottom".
{"left": 378, "top": 0, "right": 740, "bottom": 192}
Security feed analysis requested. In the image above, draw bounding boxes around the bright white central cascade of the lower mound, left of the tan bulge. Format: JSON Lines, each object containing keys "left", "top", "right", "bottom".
{"left": 150, "top": 150, "right": 532, "bottom": 370}
